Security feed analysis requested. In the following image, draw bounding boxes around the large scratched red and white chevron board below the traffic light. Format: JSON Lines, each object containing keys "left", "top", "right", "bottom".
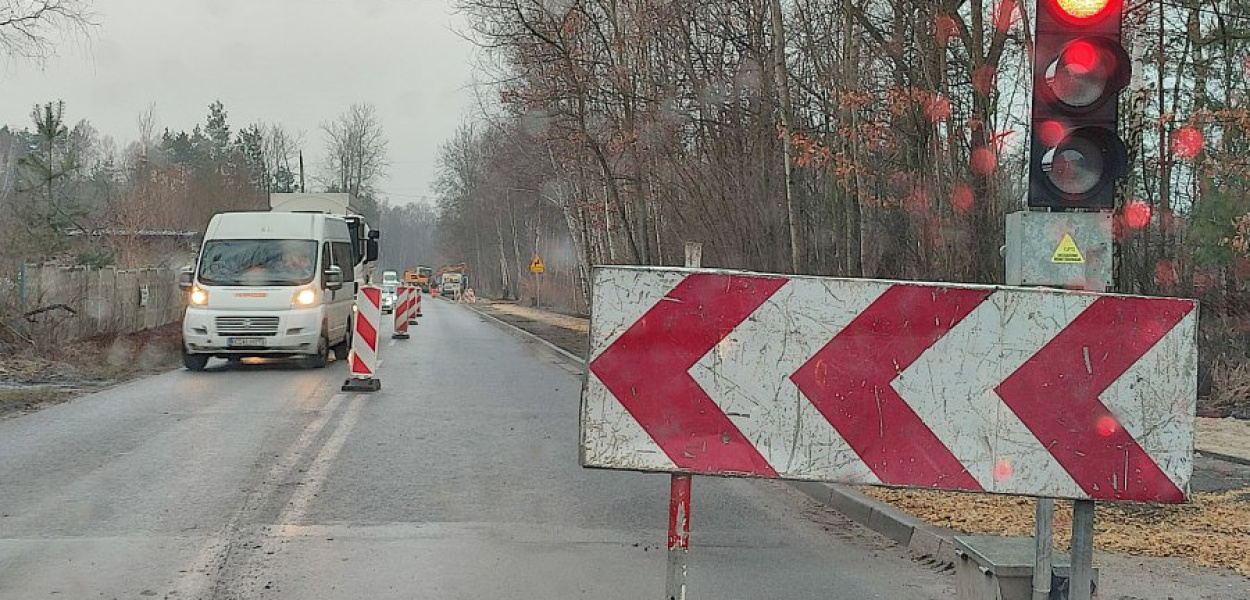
{"left": 581, "top": 268, "right": 1198, "bottom": 503}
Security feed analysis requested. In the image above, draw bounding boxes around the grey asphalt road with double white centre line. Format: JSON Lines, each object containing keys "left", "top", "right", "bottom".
{"left": 0, "top": 298, "right": 954, "bottom": 600}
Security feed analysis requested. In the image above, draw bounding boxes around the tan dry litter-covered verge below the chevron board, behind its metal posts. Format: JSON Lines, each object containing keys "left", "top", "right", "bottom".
{"left": 860, "top": 488, "right": 1250, "bottom": 576}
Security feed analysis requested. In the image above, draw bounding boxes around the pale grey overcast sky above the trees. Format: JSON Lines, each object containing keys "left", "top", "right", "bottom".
{"left": 0, "top": 0, "right": 475, "bottom": 204}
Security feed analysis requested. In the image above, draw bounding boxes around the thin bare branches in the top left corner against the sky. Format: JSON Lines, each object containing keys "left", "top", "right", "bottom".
{"left": 0, "top": 0, "right": 95, "bottom": 61}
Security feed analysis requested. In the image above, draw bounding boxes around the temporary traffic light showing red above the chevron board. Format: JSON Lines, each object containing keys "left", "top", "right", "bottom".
{"left": 1029, "top": 0, "right": 1133, "bottom": 210}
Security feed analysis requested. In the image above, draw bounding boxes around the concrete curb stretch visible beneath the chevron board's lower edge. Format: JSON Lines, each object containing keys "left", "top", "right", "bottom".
{"left": 788, "top": 481, "right": 958, "bottom": 566}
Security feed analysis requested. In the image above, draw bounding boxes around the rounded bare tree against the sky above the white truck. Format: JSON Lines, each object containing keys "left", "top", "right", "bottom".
{"left": 321, "top": 104, "right": 390, "bottom": 198}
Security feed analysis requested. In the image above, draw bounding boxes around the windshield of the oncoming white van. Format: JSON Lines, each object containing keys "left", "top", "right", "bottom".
{"left": 200, "top": 240, "right": 316, "bottom": 285}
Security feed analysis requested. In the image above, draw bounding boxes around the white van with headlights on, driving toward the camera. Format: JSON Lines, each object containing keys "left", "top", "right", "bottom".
{"left": 183, "top": 213, "right": 361, "bottom": 371}
